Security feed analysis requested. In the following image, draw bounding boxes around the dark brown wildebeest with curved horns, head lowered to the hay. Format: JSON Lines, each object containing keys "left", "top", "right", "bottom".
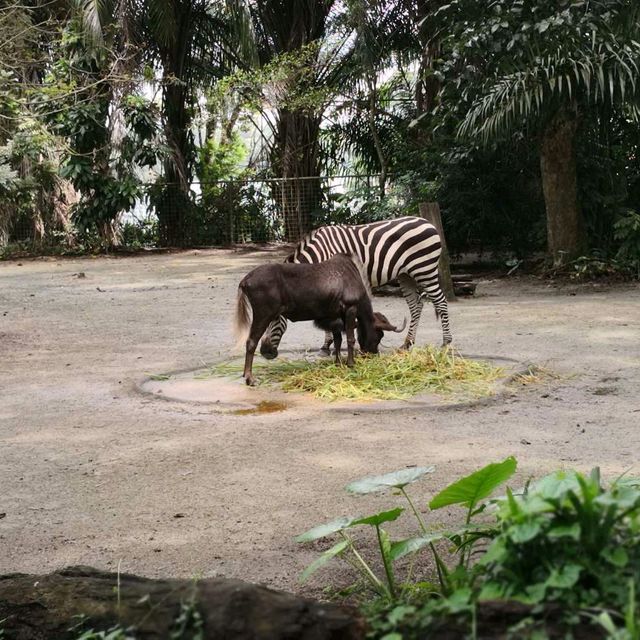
{"left": 235, "top": 254, "right": 406, "bottom": 386}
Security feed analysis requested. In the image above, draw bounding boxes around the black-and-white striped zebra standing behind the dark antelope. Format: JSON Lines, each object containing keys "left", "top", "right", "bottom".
{"left": 260, "top": 216, "right": 452, "bottom": 359}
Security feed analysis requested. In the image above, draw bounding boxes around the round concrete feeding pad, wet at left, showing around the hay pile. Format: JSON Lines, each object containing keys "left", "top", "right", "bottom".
{"left": 138, "top": 352, "right": 528, "bottom": 415}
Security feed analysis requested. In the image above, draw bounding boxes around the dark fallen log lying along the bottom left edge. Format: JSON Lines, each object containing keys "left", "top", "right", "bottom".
{"left": 0, "top": 567, "right": 365, "bottom": 640}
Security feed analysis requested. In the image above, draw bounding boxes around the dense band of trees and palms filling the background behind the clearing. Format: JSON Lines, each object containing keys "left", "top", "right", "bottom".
{"left": 0, "top": 0, "right": 640, "bottom": 275}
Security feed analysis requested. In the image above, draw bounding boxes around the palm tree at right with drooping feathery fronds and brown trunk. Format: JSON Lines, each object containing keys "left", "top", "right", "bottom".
{"left": 450, "top": 0, "right": 640, "bottom": 265}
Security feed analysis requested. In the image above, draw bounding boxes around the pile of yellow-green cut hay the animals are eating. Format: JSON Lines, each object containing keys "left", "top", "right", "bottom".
{"left": 198, "top": 347, "right": 504, "bottom": 402}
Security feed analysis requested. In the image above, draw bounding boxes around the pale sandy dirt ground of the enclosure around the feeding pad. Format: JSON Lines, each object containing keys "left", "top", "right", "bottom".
{"left": 0, "top": 251, "right": 640, "bottom": 592}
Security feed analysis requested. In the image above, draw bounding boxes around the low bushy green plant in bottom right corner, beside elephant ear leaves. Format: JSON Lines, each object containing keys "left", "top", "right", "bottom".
{"left": 480, "top": 470, "right": 640, "bottom": 611}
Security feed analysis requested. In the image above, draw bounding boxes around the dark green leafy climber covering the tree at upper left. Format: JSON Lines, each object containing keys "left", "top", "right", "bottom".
{"left": 43, "top": 21, "right": 161, "bottom": 244}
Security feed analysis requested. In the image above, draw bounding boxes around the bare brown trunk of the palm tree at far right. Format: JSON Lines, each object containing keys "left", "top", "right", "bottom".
{"left": 540, "top": 112, "right": 585, "bottom": 266}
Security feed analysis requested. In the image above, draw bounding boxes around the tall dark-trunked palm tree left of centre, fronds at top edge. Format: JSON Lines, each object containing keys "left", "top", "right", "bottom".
{"left": 75, "top": 0, "right": 249, "bottom": 246}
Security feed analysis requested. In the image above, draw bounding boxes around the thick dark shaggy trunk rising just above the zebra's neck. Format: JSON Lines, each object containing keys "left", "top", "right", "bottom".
{"left": 271, "top": 109, "right": 322, "bottom": 242}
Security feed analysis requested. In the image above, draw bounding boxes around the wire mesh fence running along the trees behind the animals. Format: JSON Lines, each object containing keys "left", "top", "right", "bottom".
{"left": 0, "top": 175, "right": 400, "bottom": 252}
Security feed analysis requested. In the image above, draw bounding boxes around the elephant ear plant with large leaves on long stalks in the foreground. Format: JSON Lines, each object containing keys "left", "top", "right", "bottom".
{"left": 296, "top": 457, "right": 516, "bottom": 601}
